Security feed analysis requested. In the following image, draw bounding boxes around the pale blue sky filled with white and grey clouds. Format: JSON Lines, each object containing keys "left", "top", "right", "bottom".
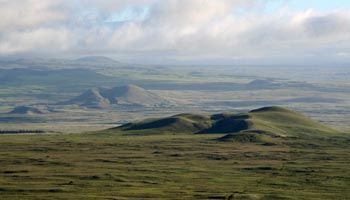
{"left": 0, "top": 0, "right": 350, "bottom": 65}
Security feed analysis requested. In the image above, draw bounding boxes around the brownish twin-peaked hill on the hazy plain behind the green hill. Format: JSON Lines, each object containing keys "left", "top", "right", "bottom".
{"left": 62, "top": 85, "right": 169, "bottom": 107}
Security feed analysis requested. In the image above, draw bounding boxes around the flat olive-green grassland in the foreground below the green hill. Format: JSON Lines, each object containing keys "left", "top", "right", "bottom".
{"left": 0, "top": 132, "right": 350, "bottom": 200}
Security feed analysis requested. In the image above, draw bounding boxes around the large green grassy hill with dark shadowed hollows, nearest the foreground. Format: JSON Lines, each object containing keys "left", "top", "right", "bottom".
{"left": 107, "top": 106, "right": 338, "bottom": 142}
